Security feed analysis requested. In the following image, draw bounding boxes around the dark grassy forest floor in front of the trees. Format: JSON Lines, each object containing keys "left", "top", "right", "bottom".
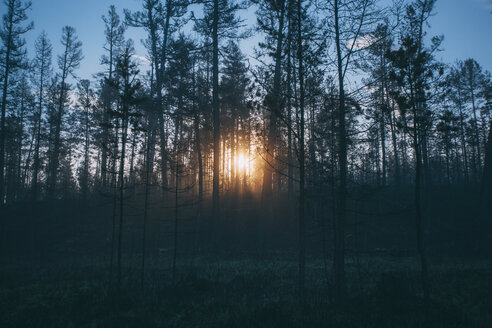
{"left": 0, "top": 254, "right": 492, "bottom": 328}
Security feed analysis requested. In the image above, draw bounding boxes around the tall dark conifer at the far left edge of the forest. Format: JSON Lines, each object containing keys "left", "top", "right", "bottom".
{"left": 0, "top": 0, "right": 34, "bottom": 205}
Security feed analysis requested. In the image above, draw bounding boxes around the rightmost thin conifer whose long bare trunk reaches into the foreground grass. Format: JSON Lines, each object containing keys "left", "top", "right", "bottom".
{"left": 388, "top": 0, "right": 442, "bottom": 300}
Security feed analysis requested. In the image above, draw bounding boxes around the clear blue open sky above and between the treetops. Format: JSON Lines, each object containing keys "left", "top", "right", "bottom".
{"left": 0, "top": 0, "right": 492, "bottom": 79}
